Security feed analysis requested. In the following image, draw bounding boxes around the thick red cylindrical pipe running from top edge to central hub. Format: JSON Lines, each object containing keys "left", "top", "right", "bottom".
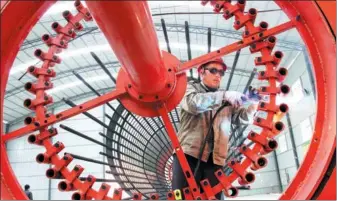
{"left": 87, "top": 1, "right": 168, "bottom": 94}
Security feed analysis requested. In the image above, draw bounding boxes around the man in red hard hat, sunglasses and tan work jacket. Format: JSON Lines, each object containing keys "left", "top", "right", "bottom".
{"left": 172, "top": 59, "right": 260, "bottom": 200}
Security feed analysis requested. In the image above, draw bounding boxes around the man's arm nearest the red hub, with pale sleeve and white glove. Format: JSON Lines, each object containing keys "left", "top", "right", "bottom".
{"left": 181, "top": 85, "right": 242, "bottom": 115}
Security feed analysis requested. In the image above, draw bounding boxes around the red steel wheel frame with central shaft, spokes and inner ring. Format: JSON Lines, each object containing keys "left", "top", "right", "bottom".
{"left": 0, "top": 1, "right": 336, "bottom": 199}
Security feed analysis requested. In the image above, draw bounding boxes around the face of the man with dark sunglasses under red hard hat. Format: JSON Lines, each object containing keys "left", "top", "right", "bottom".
{"left": 201, "top": 63, "right": 225, "bottom": 88}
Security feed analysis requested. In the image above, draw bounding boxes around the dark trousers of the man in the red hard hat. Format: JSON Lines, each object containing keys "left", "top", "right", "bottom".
{"left": 172, "top": 154, "right": 222, "bottom": 200}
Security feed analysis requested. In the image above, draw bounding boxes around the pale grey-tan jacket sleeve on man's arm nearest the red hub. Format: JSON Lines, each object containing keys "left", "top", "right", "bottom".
{"left": 180, "top": 84, "right": 224, "bottom": 115}
